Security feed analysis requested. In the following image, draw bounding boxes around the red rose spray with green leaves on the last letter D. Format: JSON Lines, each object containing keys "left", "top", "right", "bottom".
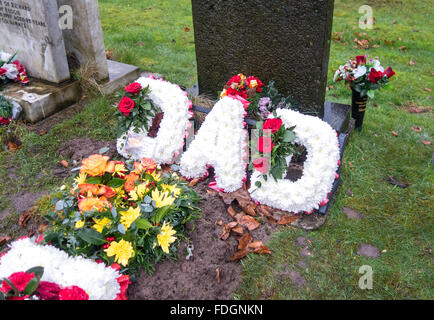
{"left": 249, "top": 115, "right": 297, "bottom": 188}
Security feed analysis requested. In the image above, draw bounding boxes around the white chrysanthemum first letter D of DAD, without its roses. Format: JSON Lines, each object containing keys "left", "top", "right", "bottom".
{"left": 117, "top": 77, "right": 193, "bottom": 164}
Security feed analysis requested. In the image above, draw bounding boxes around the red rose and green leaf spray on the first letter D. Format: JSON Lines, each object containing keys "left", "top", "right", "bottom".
{"left": 115, "top": 82, "right": 164, "bottom": 137}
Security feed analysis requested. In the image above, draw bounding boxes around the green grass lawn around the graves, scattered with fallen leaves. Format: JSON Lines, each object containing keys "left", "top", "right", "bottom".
{"left": 0, "top": 0, "right": 434, "bottom": 299}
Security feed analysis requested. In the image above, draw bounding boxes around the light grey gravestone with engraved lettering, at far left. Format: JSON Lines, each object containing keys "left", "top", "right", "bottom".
{"left": 0, "top": 0, "right": 70, "bottom": 83}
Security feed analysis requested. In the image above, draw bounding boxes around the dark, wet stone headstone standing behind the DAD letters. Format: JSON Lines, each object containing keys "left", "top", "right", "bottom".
{"left": 192, "top": 0, "right": 334, "bottom": 117}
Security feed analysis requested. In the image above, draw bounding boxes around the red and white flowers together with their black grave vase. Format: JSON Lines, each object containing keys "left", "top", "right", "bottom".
{"left": 333, "top": 55, "right": 395, "bottom": 131}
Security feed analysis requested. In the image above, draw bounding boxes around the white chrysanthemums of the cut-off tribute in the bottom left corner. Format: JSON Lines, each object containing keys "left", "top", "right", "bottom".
{"left": 0, "top": 238, "right": 121, "bottom": 300}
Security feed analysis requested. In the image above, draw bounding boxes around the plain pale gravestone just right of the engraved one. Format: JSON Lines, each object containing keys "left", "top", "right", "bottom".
{"left": 57, "top": 0, "right": 109, "bottom": 80}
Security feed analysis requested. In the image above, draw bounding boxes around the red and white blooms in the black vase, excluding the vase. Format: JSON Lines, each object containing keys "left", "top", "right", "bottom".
{"left": 333, "top": 55, "right": 395, "bottom": 98}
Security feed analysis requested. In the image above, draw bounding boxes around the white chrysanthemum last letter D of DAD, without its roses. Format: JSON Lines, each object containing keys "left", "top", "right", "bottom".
{"left": 249, "top": 109, "right": 340, "bottom": 213}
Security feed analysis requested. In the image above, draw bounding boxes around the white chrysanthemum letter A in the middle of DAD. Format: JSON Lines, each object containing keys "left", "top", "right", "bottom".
{"left": 181, "top": 97, "right": 247, "bottom": 192}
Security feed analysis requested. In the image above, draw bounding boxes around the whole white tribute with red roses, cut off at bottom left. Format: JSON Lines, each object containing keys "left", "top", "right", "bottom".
{"left": 0, "top": 237, "right": 130, "bottom": 300}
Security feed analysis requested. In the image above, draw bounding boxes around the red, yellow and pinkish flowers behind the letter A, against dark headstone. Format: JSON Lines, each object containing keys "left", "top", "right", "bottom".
{"left": 220, "top": 73, "right": 297, "bottom": 120}
